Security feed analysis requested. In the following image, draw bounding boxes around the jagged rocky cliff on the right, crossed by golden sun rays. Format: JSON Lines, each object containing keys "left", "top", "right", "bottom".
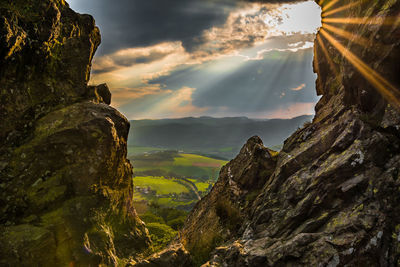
{"left": 138, "top": 0, "right": 400, "bottom": 267}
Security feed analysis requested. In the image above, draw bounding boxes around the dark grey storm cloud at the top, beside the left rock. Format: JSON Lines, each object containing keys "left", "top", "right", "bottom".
{"left": 70, "top": 0, "right": 239, "bottom": 54}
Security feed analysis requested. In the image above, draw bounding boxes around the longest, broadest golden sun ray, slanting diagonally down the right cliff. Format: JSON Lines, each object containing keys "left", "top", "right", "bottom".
{"left": 320, "top": 29, "right": 400, "bottom": 108}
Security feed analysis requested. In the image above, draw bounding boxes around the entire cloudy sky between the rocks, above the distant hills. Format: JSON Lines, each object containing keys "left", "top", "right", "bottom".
{"left": 68, "top": 0, "right": 321, "bottom": 119}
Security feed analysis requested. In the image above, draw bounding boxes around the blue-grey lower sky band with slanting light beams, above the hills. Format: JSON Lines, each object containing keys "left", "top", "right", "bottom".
{"left": 111, "top": 49, "right": 318, "bottom": 118}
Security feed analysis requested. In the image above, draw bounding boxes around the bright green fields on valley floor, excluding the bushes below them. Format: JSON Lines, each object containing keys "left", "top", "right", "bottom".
{"left": 129, "top": 151, "right": 227, "bottom": 211}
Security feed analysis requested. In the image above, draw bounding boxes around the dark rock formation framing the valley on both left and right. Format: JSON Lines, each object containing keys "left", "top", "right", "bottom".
{"left": 0, "top": 0, "right": 400, "bottom": 267}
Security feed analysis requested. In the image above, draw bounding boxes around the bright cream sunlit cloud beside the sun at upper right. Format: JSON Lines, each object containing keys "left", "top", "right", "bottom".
{"left": 181, "top": 2, "right": 319, "bottom": 61}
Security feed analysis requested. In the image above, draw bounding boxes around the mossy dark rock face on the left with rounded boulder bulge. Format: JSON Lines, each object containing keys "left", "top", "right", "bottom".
{"left": 0, "top": 0, "right": 150, "bottom": 266}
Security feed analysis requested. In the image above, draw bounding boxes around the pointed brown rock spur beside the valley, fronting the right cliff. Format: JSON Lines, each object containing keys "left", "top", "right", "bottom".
{"left": 181, "top": 137, "right": 277, "bottom": 263}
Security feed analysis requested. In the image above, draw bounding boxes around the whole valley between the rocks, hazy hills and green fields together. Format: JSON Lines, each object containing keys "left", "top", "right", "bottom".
{"left": 128, "top": 116, "right": 311, "bottom": 251}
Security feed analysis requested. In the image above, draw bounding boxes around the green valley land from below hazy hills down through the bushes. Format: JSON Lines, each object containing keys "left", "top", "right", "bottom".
{"left": 128, "top": 152, "right": 227, "bottom": 254}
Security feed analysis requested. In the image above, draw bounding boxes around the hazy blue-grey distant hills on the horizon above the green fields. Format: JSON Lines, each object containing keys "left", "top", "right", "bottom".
{"left": 128, "top": 115, "right": 312, "bottom": 158}
